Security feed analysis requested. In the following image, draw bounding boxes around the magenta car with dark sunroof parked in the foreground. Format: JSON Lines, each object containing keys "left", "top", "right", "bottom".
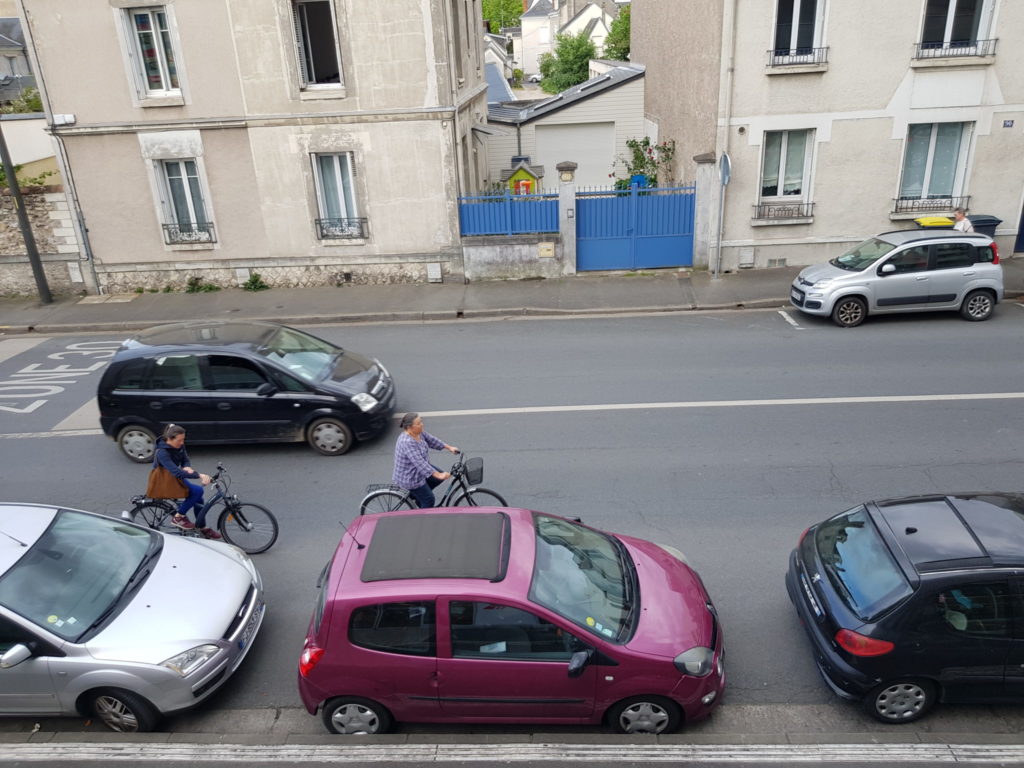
{"left": 299, "top": 507, "right": 725, "bottom": 734}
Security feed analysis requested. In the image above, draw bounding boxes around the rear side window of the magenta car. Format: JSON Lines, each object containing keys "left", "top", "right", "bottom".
{"left": 348, "top": 601, "right": 437, "bottom": 656}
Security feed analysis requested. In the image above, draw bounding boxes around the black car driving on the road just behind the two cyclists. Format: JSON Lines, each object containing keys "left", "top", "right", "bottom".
{"left": 96, "top": 322, "right": 395, "bottom": 463}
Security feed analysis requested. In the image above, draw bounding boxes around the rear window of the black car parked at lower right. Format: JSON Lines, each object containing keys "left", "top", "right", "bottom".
{"left": 814, "top": 507, "right": 912, "bottom": 622}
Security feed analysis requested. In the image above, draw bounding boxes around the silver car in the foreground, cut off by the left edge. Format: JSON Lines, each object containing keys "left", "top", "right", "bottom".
{"left": 0, "top": 504, "right": 264, "bottom": 732}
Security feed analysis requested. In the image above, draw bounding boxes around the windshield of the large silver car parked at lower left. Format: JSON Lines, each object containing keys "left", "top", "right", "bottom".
{"left": 0, "top": 510, "right": 156, "bottom": 642}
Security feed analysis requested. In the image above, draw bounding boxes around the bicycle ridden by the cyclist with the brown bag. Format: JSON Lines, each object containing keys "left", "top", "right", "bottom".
{"left": 121, "top": 464, "right": 278, "bottom": 555}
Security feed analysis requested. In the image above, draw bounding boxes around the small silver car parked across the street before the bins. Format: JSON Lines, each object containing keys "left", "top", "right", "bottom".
{"left": 790, "top": 229, "right": 1002, "bottom": 328}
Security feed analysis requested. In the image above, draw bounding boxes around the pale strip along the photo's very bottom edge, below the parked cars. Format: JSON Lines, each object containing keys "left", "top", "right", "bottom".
{"left": 4, "top": 736, "right": 1024, "bottom": 765}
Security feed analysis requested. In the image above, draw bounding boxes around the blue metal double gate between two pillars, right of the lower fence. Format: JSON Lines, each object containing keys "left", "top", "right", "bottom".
{"left": 575, "top": 185, "right": 696, "bottom": 271}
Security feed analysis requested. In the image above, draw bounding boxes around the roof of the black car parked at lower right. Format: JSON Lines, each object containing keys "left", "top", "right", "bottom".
{"left": 874, "top": 494, "right": 1024, "bottom": 573}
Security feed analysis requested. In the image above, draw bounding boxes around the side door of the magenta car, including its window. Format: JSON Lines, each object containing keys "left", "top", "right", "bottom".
{"left": 437, "top": 600, "right": 597, "bottom": 723}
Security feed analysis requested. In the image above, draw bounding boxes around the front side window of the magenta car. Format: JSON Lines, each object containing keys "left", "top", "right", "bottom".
{"left": 449, "top": 600, "right": 586, "bottom": 662}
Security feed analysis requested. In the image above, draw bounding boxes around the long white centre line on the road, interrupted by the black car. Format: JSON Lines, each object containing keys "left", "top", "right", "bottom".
{"left": 6, "top": 392, "right": 1024, "bottom": 439}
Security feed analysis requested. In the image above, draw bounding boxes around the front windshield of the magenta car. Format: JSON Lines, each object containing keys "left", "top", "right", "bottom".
{"left": 529, "top": 514, "right": 639, "bottom": 641}
